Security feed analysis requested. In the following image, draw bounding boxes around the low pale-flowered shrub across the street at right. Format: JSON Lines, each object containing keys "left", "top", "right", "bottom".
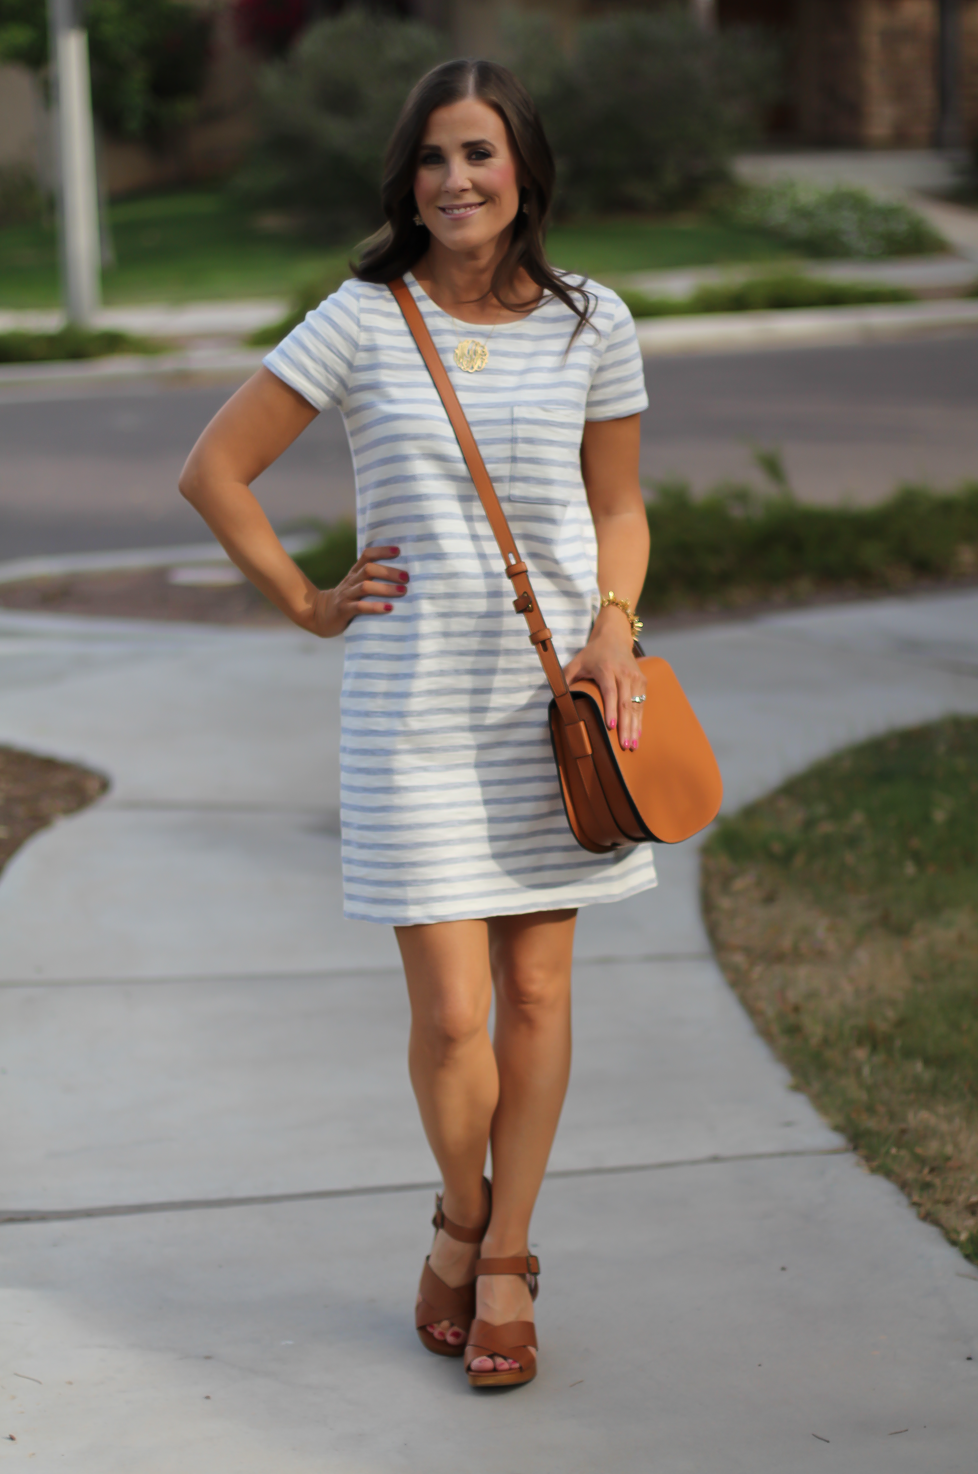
{"left": 732, "top": 180, "right": 947, "bottom": 258}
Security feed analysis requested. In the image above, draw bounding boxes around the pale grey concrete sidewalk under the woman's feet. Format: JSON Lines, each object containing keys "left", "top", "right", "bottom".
{"left": 0, "top": 593, "right": 978, "bottom": 1474}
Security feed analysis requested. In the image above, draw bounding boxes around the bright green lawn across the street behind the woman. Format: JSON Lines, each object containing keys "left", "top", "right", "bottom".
{"left": 0, "top": 190, "right": 785, "bottom": 308}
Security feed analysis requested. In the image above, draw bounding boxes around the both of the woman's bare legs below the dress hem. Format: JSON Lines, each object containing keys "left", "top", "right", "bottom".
{"left": 395, "top": 911, "right": 576, "bottom": 1371}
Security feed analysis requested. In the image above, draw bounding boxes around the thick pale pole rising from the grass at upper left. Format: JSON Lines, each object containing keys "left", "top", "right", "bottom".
{"left": 47, "top": 0, "right": 102, "bottom": 324}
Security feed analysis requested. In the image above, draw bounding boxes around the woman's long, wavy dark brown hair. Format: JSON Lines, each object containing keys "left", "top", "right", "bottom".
{"left": 352, "top": 59, "right": 594, "bottom": 336}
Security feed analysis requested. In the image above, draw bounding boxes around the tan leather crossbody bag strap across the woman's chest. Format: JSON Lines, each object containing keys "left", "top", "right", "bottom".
{"left": 387, "top": 277, "right": 591, "bottom": 737}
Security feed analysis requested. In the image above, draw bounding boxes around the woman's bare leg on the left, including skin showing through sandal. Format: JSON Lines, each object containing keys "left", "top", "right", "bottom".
{"left": 395, "top": 921, "right": 499, "bottom": 1346}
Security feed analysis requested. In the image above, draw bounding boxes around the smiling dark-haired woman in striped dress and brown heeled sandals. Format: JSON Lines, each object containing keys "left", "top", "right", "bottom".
{"left": 180, "top": 60, "right": 655, "bottom": 1387}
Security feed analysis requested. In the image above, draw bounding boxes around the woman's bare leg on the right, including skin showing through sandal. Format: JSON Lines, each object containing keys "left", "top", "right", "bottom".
{"left": 471, "top": 911, "right": 576, "bottom": 1372}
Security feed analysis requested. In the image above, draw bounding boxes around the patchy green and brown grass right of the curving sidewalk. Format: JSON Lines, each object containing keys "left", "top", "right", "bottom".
{"left": 703, "top": 718, "right": 978, "bottom": 1263}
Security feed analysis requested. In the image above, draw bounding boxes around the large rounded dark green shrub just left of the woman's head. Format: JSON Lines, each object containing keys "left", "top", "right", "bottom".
{"left": 236, "top": 9, "right": 445, "bottom": 240}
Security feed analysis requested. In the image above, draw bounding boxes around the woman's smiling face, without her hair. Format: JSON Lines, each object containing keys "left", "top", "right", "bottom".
{"left": 414, "top": 97, "right": 520, "bottom": 252}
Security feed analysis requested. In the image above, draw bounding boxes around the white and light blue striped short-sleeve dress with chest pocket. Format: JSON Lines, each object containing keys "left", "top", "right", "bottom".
{"left": 265, "top": 273, "right": 655, "bottom": 926}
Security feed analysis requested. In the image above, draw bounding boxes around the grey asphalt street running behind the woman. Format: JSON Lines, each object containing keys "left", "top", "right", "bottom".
{"left": 0, "top": 333, "right": 978, "bottom": 560}
